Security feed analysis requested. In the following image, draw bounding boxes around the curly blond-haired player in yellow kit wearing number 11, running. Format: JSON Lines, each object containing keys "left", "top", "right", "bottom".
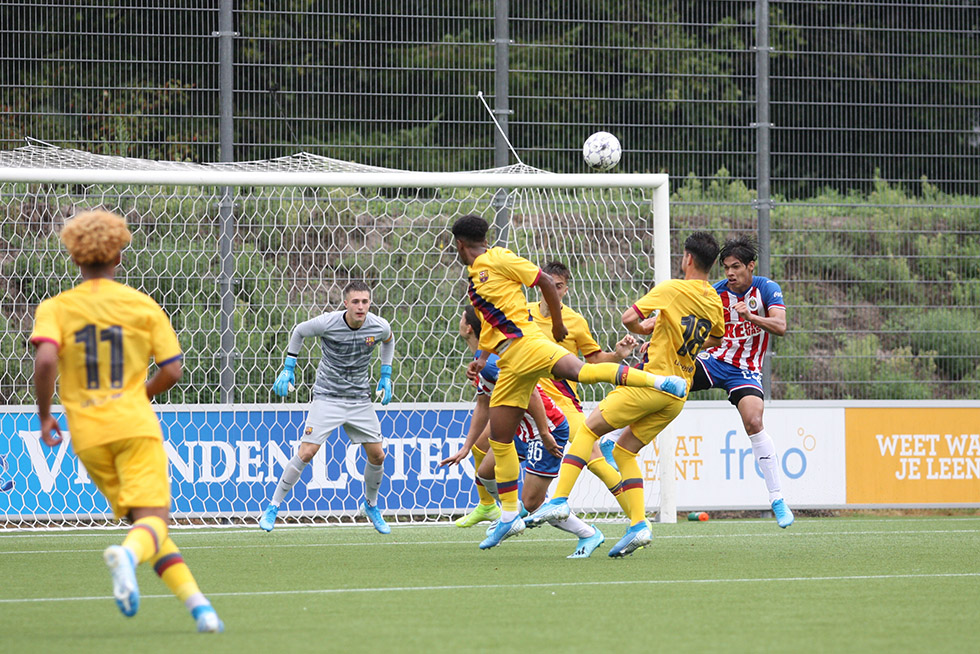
{"left": 31, "top": 211, "right": 224, "bottom": 632}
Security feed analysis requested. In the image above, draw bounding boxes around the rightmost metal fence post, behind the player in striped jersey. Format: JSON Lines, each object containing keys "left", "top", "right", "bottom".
{"left": 755, "top": 0, "right": 772, "bottom": 399}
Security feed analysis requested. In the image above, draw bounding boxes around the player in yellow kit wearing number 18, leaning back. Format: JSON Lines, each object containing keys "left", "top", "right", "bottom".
{"left": 527, "top": 232, "right": 725, "bottom": 557}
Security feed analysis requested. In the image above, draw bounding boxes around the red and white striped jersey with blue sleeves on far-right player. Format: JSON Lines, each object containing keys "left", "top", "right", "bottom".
{"left": 705, "top": 276, "right": 786, "bottom": 371}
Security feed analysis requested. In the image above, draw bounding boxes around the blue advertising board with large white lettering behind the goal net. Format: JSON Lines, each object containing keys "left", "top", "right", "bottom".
{"left": 0, "top": 404, "right": 476, "bottom": 520}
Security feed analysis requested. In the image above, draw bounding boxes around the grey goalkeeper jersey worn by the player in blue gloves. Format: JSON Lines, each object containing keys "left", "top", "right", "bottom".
{"left": 287, "top": 311, "right": 391, "bottom": 400}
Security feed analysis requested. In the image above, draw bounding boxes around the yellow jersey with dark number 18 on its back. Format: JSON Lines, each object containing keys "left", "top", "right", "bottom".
{"left": 633, "top": 279, "right": 725, "bottom": 388}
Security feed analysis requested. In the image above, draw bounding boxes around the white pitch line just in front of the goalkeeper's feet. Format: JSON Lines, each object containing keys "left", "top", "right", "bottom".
{"left": 0, "top": 529, "right": 980, "bottom": 556}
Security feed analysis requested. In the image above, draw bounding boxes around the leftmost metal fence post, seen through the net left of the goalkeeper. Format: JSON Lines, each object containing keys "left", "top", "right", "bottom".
{"left": 217, "top": 0, "right": 235, "bottom": 404}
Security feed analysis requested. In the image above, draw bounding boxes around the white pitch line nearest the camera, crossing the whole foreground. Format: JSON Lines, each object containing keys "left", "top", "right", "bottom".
{"left": 0, "top": 572, "right": 980, "bottom": 604}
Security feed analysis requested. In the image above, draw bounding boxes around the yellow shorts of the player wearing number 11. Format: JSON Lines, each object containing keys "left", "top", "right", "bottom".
{"left": 78, "top": 438, "right": 170, "bottom": 518}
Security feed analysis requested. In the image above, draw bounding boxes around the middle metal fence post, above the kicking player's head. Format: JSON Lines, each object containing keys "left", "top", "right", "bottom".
{"left": 493, "top": 0, "right": 510, "bottom": 247}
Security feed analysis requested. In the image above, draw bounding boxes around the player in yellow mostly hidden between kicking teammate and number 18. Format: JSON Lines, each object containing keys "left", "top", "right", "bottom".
{"left": 528, "top": 261, "right": 637, "bottom": 511}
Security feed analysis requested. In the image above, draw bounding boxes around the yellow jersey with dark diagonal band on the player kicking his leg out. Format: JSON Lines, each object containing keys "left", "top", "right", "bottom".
{"left": 467, "top": 247, "right": 541, "bottom": 354}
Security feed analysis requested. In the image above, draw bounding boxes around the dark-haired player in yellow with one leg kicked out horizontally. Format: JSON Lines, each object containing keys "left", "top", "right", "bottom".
{"left": 452, "top": 215, "right": 687, "bottom": 549}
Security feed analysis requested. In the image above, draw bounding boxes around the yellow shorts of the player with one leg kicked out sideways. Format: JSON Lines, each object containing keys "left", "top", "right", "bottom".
{"left": 490, "top": 334, "right": 570, "bottom": 409}
